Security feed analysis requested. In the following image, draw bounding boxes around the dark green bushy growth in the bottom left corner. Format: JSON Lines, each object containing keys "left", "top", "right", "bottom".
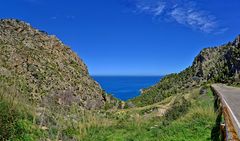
{"left": 0, "top": 88, "right": 45, "bottom": 141}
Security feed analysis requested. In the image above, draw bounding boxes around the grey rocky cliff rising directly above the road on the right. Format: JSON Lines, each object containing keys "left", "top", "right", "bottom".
{"left": 192, "top": 36, "right": 240, "bottom": 83}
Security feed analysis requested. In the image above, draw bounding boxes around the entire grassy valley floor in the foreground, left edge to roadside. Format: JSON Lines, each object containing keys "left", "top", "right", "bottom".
{"left": 0, "top": 83, "right": 216, "bottom": 141}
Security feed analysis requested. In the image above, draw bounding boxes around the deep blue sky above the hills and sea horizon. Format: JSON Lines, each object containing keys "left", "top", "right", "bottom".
{"left": 0, "top": 0, "right": 240, "bottom": 75}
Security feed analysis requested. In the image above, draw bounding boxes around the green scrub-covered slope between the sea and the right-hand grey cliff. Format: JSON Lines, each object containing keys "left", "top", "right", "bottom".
{"left": 129, "top": 68, "right": 195, "bottom": 106}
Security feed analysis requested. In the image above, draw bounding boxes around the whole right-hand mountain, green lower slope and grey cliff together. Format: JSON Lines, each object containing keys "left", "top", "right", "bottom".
{"left": 128, "top": 36, "right": 240, "bottom": 106}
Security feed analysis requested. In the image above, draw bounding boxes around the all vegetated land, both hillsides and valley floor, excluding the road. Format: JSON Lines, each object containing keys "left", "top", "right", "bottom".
{"left": 0, "top": 20, "right": 240, "bottom": 141}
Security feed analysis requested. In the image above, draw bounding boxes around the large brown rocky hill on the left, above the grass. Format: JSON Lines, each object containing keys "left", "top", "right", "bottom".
{"left": 0, "top": 19, "right": 105, "bottom": 109}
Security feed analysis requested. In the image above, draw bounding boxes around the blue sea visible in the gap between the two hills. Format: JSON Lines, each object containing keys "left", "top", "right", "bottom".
{"left": 93, "top": 76, "right": 162, "bottom": 100}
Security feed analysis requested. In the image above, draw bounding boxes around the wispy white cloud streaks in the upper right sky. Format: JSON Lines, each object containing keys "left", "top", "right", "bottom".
{"left": 131, "top": 0, "right": 227, "bottom": 33}
